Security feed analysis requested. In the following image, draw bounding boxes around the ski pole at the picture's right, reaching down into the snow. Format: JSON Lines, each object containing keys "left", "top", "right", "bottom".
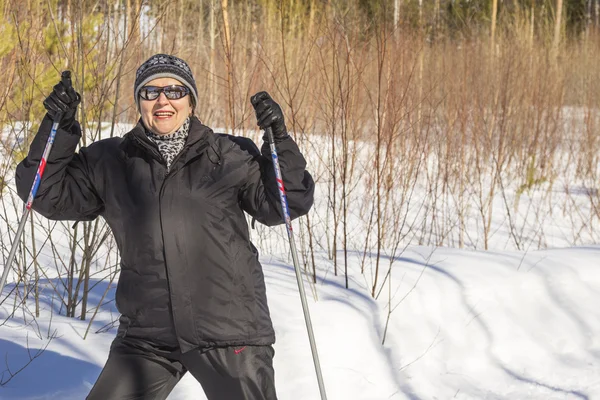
{"left": 266, "top": 127, "right": 327, "bottom": 400}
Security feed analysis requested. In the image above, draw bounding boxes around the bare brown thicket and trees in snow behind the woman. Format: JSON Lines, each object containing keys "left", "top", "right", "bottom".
{"left": 0, "top": 0, "right": 600, "bottom": 340}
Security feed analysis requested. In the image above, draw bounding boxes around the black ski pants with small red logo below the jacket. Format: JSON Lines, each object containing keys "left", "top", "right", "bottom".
{"left": 87, "top": 337, "right": 277, "bottom": 400}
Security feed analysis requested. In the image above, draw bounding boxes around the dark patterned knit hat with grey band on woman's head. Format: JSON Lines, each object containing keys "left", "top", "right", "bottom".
{"left": 133, "top": 54, "right": 198, "bottom": 110}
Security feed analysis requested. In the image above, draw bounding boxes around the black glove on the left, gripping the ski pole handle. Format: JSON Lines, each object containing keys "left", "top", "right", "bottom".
{"left": 44, "top": 71, "right": 81, "bottom": 128}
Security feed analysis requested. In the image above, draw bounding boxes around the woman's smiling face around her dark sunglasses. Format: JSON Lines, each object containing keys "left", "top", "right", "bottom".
{"left": 140, "top": 78, "right": 192, "bottom": 135}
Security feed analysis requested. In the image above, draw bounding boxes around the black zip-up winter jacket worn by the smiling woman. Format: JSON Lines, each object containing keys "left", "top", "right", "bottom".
{"left": 16, "top": 117, "right": 314, "bottom": 352}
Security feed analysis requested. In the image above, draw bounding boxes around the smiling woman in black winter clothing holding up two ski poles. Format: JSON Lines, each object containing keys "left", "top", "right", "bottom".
{"left": 16, "top": 54, "right": 314, "bottom": 400}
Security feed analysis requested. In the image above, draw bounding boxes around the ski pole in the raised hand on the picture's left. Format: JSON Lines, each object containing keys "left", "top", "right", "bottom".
{"left": 0, "top": 71, "right": 71, "bottom": 296}
